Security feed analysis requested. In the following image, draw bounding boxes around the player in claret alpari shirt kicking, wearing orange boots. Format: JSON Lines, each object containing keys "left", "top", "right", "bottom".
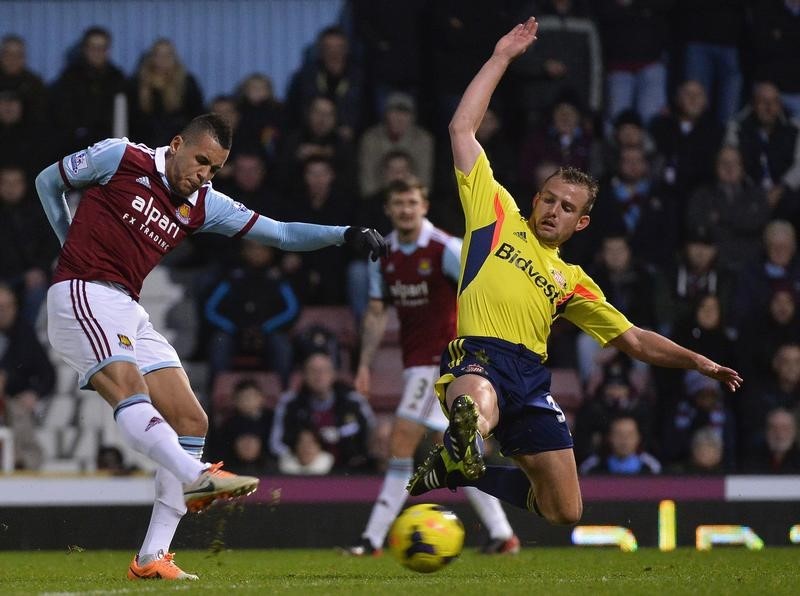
{"left": 36, "top": 114, "right": 386, "bottom": 579}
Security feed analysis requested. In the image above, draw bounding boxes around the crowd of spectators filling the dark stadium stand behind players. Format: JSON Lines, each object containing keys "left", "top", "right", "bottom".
{"left": 0, "top": 0, "right": 800, "bottom": 474}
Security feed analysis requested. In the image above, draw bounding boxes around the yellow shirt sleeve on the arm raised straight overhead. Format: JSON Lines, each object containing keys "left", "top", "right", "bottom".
{"left": 455, "top": 151, "right": 519, "bottom": 229}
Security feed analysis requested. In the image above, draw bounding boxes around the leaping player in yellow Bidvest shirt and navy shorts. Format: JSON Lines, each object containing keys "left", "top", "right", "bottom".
{"left": 408, "top": 17, "right": 742, "bottom": 524}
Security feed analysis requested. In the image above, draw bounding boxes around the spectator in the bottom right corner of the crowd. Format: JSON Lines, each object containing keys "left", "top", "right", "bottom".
{"left": 742, "top": 407, "right": 800, "bottom": 474}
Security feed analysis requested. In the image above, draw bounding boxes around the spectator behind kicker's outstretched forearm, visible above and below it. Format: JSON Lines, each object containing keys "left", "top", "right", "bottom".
{"left": 284, "top": 157, "right": 354, "bottom": 305}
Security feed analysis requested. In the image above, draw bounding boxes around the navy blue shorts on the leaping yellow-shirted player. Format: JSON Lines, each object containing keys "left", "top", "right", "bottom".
{"left": 435, "top": 337, "right": 573, "bottom": 456}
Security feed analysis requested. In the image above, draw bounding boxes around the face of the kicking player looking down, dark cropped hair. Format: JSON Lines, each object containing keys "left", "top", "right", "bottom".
{"left": 166, "top": 134, "right": 229, "bottom": 197}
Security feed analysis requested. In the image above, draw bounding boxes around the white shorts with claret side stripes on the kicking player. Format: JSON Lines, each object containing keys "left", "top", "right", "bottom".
{"left": 47, "top": 279, "right": 181, "bottom": 389}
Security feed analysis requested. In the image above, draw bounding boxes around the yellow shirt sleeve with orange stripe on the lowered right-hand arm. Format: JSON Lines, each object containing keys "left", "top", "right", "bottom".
{"left": 559, "top": 267, "right": 633, "bottom": 346}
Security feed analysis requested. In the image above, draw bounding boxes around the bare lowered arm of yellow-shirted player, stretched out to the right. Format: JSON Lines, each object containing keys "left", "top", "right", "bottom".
{"left": 609, "top": 327, "right": 742, "bottom": 391}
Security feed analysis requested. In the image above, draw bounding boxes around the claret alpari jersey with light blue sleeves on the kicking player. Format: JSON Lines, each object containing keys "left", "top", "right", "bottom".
{"left": 36, "top": 138, "right": 346, "bottom": 299}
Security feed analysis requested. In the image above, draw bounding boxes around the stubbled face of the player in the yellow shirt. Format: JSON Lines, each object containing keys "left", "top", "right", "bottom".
{"left": 530, "top": 177, "right": 589, "bottom": 247}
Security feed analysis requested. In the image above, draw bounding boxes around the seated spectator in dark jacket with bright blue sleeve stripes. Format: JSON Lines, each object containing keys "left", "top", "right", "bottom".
{"left": 205, "top": 239, "right": 300, "bottom": 386}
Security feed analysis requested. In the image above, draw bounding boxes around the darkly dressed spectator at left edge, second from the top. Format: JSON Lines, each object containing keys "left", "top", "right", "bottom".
{"left": 0, "top": 91, "right": 47, "bottom": 179}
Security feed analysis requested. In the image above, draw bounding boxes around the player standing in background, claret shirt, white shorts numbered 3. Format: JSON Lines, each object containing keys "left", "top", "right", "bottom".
{"left": 347, "top": 180, "right": 519, "bottom": 556}
